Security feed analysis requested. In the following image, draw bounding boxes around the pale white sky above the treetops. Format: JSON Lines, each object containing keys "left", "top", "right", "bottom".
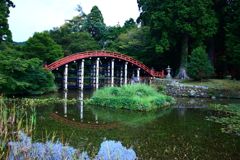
{"left": 8, "top": 0, "right": 140, "bottom": 42}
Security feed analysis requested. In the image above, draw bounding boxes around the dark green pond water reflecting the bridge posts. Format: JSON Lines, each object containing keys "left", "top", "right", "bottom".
{"left": 12, "top": 90, "right": 240, "bottom": 160}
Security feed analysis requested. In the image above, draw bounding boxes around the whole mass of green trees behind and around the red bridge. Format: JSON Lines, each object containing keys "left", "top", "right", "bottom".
{"left": 0, "top": 0, "right": 240, "bottom": 94}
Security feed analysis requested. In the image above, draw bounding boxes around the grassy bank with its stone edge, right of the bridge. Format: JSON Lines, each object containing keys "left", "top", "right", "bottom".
{"left": 153, "top": 79, "right": 240, "bottom": 98}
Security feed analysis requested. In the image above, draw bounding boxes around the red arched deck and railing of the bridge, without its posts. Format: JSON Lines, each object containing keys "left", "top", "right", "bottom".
{"left": 44, "top": 51, "right": 164, "bottom": 78}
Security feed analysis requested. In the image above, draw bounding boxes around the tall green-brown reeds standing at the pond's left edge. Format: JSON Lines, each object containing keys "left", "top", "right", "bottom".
{"left": 0, "top": 97, "right": 36, "bottom": 159}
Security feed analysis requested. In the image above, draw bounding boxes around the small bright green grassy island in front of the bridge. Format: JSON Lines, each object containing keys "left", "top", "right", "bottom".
{"left": 85, "top": 84, "right": 174, "bottom": 111}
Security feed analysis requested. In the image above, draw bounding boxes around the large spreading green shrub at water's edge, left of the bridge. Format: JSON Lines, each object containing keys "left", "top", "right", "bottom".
{"left": 0, "top": 43, "right": 56, "bottom": 94}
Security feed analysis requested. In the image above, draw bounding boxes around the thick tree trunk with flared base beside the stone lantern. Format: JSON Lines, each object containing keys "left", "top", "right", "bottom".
{"left": 175, "top": 33, "right": 190, "bottom": 79}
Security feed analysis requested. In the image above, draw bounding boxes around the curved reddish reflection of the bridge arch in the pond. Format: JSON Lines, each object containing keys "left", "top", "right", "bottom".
{"left": 50, "top": 112, "right": 121, "bottom": 130}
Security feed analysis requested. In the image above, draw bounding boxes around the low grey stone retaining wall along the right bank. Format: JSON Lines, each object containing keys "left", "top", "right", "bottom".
{"left": 153, "top": 79, "right": 240, "bottom": 98}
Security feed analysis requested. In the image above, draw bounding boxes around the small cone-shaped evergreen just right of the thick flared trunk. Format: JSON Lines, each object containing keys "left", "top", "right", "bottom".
{"left": 187, "top": 47, "right": 214, "bottom": 79}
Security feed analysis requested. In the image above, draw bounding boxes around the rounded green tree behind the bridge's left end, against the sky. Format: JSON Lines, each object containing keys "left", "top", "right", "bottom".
{"left": 24, "top": 31, "right": 63, "bottom": 63}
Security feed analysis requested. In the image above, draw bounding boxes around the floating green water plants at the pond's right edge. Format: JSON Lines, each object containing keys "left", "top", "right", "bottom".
{"left": 206, "top": 104, "right": 240, "bottom": 136}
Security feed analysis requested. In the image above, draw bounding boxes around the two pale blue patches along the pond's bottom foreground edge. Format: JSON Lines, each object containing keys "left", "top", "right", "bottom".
{"left": 8, "top": 132, "right": 137, "bottom": 160}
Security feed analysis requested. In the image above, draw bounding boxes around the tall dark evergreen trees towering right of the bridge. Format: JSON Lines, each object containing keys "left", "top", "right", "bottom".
{"left": 137, "top": 0, "right": 240, "bottom": 78}
